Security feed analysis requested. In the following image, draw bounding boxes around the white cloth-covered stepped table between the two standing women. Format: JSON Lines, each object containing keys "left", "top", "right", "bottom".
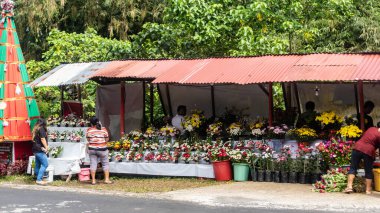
{"left": 27, "top": 142, "right": 87, "bottom": 175}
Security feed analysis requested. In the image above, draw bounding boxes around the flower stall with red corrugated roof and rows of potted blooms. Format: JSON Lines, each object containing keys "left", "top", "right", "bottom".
{"left": 32, "top": 54, "right": 380, "bottom": 183}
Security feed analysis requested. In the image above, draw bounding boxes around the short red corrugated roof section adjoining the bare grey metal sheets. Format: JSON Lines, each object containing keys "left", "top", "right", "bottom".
{"left": 91, "top": 60, "right": 180, "bottom": 79}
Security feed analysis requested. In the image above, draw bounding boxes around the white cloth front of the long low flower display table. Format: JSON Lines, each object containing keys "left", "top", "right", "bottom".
{"left": 110, "top": 162, "right": 215, "bottom": 178}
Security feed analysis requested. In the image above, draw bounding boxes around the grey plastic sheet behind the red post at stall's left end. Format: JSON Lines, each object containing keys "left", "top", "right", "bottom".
{"left": 96, "top": 82, "right": 144, "bottom": 140}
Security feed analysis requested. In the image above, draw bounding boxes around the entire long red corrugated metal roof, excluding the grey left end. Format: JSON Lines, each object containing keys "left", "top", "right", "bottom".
{"left": 91, "top": 53, "right": 380, "bottom": 84}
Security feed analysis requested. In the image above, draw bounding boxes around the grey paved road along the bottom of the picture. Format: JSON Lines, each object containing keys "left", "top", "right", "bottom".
{"left": 0, "top": 187, "right": 332, "bottom": 213}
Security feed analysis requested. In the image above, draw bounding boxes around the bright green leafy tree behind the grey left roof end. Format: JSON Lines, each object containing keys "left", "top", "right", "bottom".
{"left": 27, "top": 29, "right": 131, "bottom": 116}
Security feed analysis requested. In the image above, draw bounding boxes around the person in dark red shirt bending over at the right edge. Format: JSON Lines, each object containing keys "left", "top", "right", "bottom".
{"left": 344, "top": 127, "right": 380, "bottom": 194}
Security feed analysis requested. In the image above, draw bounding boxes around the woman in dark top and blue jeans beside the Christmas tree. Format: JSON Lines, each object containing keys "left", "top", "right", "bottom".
{"left": 32, "top": 118, "right": 49, "bottom": 185}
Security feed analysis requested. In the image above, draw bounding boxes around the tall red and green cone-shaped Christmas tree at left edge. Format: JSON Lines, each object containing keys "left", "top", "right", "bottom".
{"left": 0, "top": 0, "right": 40, "bottom": 141}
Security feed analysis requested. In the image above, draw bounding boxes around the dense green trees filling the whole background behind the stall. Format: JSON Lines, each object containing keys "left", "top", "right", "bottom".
{"left": 16, "top": 0, "right": 380, "bottom": 119}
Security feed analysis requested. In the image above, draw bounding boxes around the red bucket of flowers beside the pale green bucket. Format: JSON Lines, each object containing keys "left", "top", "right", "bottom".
{"left": 209, "top": 142, "right": 232, "bottom": 181}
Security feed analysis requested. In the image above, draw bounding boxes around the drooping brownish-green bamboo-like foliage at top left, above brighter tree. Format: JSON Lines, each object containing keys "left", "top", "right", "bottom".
{"left": 15, "top": 0, "right": 165, "bottom": 60}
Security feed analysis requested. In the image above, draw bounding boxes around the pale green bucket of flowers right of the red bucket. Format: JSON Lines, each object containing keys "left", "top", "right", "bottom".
{"left": 229, "top": 149, "right": 252, "bottom": 181}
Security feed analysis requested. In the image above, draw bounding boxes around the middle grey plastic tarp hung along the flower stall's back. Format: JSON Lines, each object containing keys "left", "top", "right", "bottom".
{"left": 159, "top": 84, "right": 268, "bottom": 118}
